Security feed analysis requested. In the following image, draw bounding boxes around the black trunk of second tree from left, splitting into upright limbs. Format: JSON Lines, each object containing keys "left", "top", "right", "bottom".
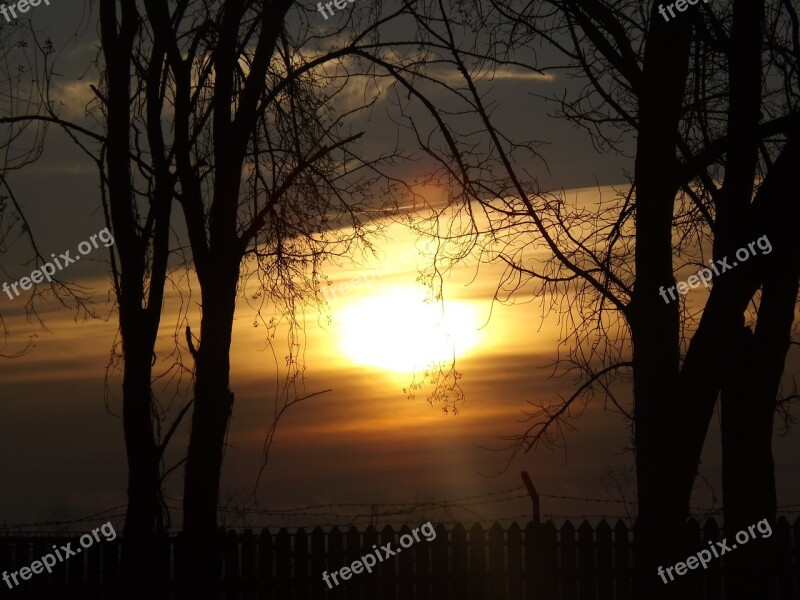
{"left": 176, "top": 0, "right": 293, "bottom": 584}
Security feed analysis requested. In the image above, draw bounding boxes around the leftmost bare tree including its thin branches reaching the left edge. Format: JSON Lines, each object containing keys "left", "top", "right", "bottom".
{"left": 2, "top": 12, "right": 188, "bottom": 597}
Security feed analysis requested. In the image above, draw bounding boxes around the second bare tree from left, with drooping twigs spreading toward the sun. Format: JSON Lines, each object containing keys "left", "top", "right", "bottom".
{"left": 125, "top": 0, "right": 434, "bottom": 594}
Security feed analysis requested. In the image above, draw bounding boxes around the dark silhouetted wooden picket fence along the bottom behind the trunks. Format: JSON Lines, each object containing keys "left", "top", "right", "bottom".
{"left": 0, "top": 517, "right": 800, "bottom": 600}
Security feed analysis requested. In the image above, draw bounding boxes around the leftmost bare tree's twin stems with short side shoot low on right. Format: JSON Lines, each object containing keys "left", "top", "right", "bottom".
{"left": 98, "top": 2, "right": 184, "bottom": 597}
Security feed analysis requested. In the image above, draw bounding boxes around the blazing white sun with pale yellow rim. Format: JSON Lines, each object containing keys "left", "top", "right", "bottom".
{"left": 336, "top": 286, "right": 479, "bottom": 373}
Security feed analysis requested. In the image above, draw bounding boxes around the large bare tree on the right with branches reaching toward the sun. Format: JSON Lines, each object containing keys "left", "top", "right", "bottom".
{"left": 390, "top": 0, "right": 797, "bottom": 598}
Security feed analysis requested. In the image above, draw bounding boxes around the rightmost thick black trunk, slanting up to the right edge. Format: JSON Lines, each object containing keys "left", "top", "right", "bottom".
{"left": 722, "top": 138, "right": 800, "bottom": 600}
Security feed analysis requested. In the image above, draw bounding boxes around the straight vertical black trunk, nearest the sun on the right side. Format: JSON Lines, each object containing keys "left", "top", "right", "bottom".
{"left": 629, "top": 10, "right": 693, "bottom": 600}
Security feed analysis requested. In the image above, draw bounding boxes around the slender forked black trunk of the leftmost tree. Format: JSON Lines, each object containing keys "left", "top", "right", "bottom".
{"left": 100, "top": 1, "right": 171, "bottom": 598}
